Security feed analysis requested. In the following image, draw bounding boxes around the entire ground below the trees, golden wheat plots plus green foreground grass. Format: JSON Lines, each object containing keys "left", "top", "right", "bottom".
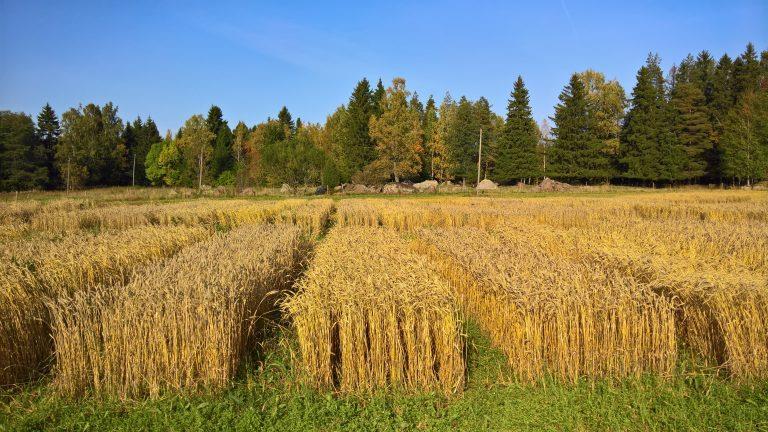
{"left": 0, "top": 187, "right": 768, "bottom": 431}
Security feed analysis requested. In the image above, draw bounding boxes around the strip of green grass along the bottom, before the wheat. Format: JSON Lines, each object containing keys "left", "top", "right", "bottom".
{"left": 0, "top": 325, "right": 768, "bottom": 431}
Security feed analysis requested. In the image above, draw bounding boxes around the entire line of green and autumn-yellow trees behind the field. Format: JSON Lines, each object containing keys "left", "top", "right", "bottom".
{"left": 0, "top": 43, "right": 768, "bottom": 191}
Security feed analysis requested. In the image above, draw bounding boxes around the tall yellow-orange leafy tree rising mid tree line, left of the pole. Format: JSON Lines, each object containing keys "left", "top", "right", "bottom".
{"left": 369, "top": 78, "right": 423, "bottom": 182}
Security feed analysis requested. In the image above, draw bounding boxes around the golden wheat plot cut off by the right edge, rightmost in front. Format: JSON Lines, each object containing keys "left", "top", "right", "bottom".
{"left": 595, "top": 245, "right": 768, "bottom": 380}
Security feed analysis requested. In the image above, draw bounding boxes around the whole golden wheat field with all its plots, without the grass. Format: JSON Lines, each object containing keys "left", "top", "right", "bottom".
{"left": 0, "top": 190, "right": 768, "bottom": 400}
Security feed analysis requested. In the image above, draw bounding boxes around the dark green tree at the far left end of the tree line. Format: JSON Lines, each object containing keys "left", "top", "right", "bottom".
{"left": 0, "top": 111, "right": 48, "bottom": 191}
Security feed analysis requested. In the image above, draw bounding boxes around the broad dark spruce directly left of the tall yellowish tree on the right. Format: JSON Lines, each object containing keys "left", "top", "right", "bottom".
{"left": 550, "top": 74, "right": 611, "bottom": 181}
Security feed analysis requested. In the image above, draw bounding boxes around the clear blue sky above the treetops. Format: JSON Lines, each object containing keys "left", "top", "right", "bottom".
{"left": 0, "top": 0, "right": 768, "bottom": 132}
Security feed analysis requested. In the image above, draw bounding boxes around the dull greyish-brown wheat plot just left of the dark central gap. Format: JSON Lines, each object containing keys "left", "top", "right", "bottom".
{"left": 48, "top": 225, "right": 307, "bottom": 398}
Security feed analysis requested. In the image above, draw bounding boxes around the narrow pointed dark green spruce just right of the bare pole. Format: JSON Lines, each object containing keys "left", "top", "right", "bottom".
{"left": 494, "top": 76, "right": 541, "bottom": 183}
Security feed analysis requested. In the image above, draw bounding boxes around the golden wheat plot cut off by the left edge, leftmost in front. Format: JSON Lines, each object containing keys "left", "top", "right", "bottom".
{"left": 0, "top": 227, "right": 210, "bottom": 385}
